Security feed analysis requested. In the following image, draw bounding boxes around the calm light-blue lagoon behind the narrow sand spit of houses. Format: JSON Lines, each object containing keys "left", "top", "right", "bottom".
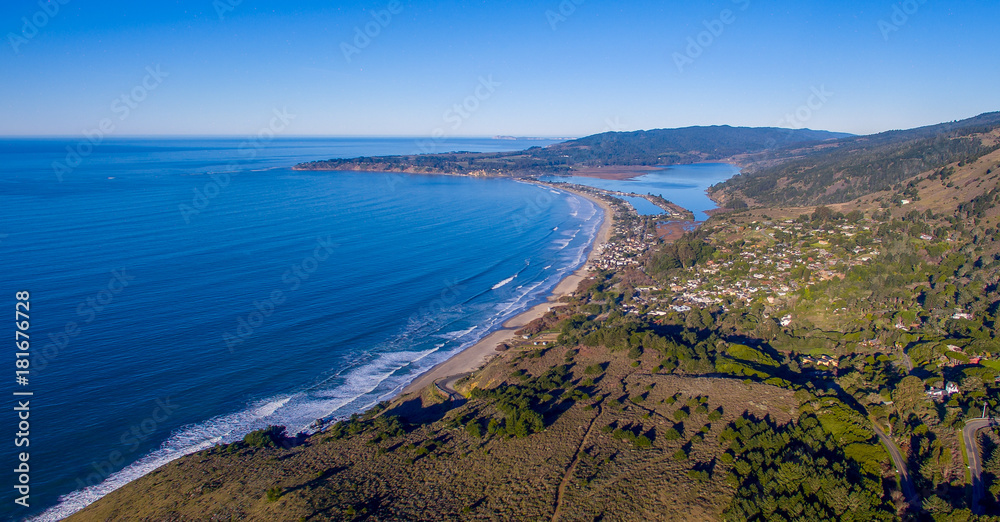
{"left": 541, "top": 163, "right": 740, "bottom": 221}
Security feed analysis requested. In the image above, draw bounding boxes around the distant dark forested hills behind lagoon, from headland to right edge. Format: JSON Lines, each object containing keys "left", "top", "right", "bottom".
{"left": 295, "top": 112, "right": 1000, "bottom": 207}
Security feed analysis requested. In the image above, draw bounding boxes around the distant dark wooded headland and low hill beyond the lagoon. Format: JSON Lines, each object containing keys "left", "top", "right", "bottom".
{"left": 294, "top": 126, "right": 850, "bottom": 176}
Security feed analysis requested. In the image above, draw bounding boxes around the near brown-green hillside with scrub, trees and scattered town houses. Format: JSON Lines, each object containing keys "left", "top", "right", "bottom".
{"left": 71, "top": 115, "right": 1000, "bottom": 522}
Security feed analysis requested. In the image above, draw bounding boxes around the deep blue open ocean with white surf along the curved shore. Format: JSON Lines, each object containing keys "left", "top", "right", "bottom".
{"left": 0, "top": 138, "right": 736, "bottom": 520}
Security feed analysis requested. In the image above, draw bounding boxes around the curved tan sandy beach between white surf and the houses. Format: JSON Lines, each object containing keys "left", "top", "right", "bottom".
{"left": 400, "top": 187, "right": 614, "bottom": 397}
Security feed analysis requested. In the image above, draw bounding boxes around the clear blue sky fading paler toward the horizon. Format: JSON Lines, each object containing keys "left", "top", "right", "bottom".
{"left": 0, "top": 0, "right": 1000, "bottom": 136}
